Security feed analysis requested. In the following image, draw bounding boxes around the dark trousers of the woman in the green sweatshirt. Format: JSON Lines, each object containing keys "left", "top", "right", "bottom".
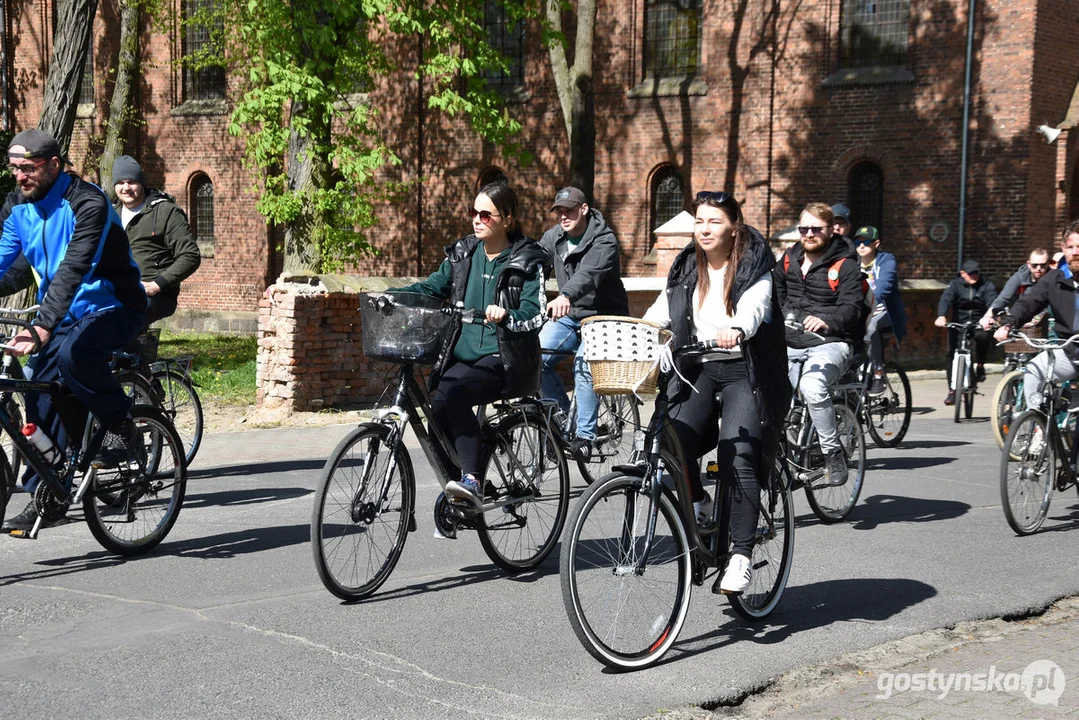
{"left": 431, "top": 355, "right": 506, "bottom": 479}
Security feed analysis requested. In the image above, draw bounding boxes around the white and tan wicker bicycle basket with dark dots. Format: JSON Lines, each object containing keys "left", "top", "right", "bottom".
{"left": 581, "top": 315, "right": 671, "bottom": 395}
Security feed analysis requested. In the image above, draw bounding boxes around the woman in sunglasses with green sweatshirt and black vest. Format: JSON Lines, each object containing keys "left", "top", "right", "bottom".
{"left": 395, "top": 182, "right": 547, "bottom": 506}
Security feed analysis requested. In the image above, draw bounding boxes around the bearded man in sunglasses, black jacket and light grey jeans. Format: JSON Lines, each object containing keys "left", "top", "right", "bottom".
{"left": 774, "top": 203, "right": 866, "bottom": 486}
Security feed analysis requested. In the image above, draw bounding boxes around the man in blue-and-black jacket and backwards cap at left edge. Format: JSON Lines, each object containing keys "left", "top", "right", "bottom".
{"left": 0, "top": 128, "right": 146, "bottom": 530}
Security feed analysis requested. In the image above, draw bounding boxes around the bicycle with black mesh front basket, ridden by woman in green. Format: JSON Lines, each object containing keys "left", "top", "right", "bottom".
{"left": 311, "top": 293, "right": 570, "bottom": 601}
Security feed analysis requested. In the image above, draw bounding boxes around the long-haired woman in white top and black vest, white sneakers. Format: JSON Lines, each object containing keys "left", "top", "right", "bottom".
{"left": 644, "top": 192, "right": 791, "bottom": 594}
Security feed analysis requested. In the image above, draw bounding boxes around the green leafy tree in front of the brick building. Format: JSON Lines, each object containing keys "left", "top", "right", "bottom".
{"left": 224, "top": 0, "right": 538, "bottom": 272}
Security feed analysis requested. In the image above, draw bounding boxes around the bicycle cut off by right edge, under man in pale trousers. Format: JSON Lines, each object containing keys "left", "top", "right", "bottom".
{"left": 1000, "top": 332, "right": 1079, "bottom": 535}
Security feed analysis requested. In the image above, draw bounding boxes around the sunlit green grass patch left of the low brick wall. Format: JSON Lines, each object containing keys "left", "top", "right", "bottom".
{"left": 158, "top": 330, "right": 258, "bottom": 405}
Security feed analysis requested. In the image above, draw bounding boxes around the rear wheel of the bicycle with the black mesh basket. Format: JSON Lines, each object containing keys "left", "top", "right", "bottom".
{"left": 476, "top": 410, "right": 570, "bottom": 572}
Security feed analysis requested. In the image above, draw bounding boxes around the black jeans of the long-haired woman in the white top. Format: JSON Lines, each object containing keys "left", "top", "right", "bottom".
{"left": 670, "top": 359, "right": 762, "bottom": 557}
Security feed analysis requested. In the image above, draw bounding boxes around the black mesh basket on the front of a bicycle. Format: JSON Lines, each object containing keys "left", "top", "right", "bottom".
{"left": 359, "top": 293, "right": 453, "bottom": 365}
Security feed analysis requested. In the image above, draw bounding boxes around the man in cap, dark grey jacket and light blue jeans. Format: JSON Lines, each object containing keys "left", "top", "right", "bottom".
{"left": 540, "top": 187, "right": 629, "bottom": 460}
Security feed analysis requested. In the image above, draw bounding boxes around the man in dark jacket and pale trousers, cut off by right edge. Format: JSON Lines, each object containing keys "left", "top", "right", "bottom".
{"left": 993, "top": 220, "right": 1079, "bottom": 408}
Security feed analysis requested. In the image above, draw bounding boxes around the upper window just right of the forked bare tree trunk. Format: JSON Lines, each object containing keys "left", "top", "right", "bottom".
{"left": 644, "top": 0, "right": 701, "bottom": 80}
